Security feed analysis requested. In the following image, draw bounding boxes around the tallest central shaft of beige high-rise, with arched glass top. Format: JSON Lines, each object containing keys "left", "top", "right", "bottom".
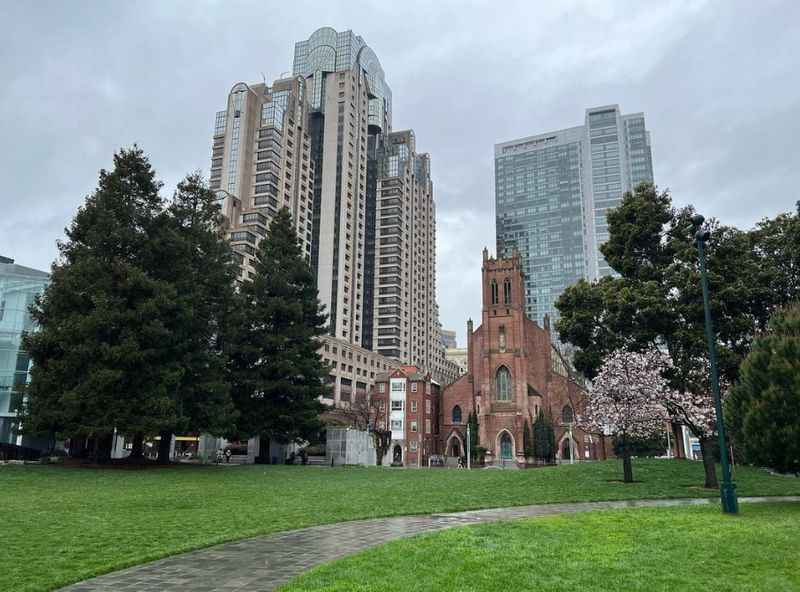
{"left": 293, "top": 27, "right": 392, "bottom": 347}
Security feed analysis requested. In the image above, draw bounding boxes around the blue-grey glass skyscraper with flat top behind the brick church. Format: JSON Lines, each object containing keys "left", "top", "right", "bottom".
{"left": 495, "top": 105, "right": 653, "bottom": 324}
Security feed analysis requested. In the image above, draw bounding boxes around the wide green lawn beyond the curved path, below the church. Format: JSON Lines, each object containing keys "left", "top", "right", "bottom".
{"left": 0, "top": 460, "right": 800, "bottom": 591}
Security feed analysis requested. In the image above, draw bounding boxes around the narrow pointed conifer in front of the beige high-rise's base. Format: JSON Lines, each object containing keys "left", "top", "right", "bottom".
{"left": 229, "top": 208, "right": 329, "bottom": 456}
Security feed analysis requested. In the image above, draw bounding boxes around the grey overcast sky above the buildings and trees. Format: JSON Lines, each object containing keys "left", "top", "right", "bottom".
{"left": 0, "top": 0, "right": 800, "bottom": 344}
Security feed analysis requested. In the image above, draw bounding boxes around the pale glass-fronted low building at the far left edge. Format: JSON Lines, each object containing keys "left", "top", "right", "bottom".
{"left": 0, "top": 258, "right": 49, "bottom": 443}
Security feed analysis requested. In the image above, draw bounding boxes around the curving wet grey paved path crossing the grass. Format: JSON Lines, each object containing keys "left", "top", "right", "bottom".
{"left": 63, "top": 496, "right": 800, "bottom": 592}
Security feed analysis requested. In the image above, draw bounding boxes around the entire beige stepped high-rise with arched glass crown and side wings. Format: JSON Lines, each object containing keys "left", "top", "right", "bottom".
{"left": 211, "top": 27, "right": 453, "bottom": 404}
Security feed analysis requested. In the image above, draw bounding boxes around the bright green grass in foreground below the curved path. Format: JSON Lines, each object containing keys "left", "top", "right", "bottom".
{"left": 281, "top": 504, "right": 800, "bottom": 592}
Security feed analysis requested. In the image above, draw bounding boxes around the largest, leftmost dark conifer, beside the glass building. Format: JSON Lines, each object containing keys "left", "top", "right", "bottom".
{"left": 24, "top": 147, "right": 181, "bottom": 456}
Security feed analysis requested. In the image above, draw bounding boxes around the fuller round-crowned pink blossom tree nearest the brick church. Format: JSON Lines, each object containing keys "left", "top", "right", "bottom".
{"left": 578, "top": 349, "right": 669, "bottom": 483}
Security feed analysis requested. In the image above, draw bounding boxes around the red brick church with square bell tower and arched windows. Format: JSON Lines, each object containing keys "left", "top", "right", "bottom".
{"left": 438, "top": 249, "right": 607, "bottom": 466}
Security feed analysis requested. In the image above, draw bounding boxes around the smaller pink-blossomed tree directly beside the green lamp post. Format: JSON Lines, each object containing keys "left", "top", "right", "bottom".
{"left": 662, "top": 356, "right": 730, "bottom": 488}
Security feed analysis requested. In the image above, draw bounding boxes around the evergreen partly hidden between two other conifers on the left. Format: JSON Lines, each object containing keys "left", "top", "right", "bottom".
{"left": 152, "top": 173, "right": 238, "bottom": 462}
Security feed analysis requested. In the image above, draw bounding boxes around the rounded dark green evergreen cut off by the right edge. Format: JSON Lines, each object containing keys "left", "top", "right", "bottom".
{"left": 725, "top": 304, "right": 800, "bottom": 473}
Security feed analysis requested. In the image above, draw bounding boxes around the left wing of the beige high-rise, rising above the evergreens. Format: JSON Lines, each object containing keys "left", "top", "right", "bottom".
{"left": 210, "top": 78, "right": 314, "bottom": 277}
